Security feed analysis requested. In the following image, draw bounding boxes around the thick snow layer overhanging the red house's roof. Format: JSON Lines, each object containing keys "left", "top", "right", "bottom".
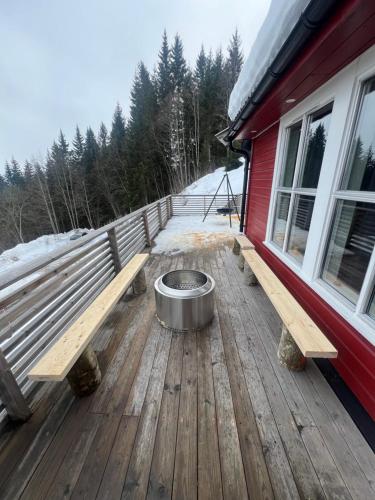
{"left": 228, "top": 0, "right": 310, "bottom": 121}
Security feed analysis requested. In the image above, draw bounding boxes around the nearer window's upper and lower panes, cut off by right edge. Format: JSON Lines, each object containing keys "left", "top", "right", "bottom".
{"left": 321, "top": 78, "right": 375, "bottom": 317}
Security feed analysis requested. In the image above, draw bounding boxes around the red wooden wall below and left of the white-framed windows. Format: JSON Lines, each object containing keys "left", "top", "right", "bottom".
{"left": 245, "top": 125, "right": 375, "bottom": 419}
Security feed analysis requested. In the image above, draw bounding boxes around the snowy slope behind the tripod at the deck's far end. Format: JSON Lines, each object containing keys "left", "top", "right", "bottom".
{"left": 181, "top": 159, "right": 244, "bottom": 194}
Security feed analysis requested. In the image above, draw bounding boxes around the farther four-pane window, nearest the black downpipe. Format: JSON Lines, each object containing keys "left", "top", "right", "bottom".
{"left": 272, "top": 103, "right": 332, "bottom": 265}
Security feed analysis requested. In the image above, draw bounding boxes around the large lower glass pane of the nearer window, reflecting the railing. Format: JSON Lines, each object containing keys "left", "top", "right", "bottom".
{"left": 322, "top": 200, "right": 375, "bottom": 303}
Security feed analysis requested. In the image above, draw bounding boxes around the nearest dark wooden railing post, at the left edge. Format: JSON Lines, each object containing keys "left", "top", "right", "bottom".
{"left": 0, "top": 350, "right": 31, "bottom": 422}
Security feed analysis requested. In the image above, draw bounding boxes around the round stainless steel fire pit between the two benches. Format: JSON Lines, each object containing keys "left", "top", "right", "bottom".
{"left": 155, "top": 269, "right": 215, "bottom": 332}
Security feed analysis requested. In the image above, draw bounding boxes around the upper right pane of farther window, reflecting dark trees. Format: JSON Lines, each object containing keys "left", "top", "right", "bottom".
{"left": 301, "top": 103, "right": 332, "bottom": 188}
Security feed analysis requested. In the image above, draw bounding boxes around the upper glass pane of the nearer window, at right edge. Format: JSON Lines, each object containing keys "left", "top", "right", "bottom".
{"left": 341, "top": 78, "right": 375, "bottom": 191}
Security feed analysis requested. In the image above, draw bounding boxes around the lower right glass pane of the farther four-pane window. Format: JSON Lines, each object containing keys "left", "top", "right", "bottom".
{"left": 287, "top": 195, "right": 315, "bottom": 263}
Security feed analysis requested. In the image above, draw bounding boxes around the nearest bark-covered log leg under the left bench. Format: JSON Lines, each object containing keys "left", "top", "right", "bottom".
{"left": 67, "top": 345, "right": 102, "bottom": 397}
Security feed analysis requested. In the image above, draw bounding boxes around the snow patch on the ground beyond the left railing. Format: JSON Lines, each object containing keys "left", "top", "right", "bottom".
{"left": 0, "top": 229, "right": 90, "bottom": 272}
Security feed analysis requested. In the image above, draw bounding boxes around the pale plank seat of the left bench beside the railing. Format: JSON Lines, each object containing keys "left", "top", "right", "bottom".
{"left": 28, "top": 254, "right": 149, "bottom": 382}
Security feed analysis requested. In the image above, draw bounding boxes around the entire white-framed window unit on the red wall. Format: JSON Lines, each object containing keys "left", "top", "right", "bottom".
{"left": 264, "top": 46, "right": 375, "bottom": 346}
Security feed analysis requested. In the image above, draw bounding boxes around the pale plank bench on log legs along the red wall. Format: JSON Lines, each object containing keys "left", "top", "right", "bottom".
{"left": 242, "top": 249, "right": 337, "bottom": 371}
